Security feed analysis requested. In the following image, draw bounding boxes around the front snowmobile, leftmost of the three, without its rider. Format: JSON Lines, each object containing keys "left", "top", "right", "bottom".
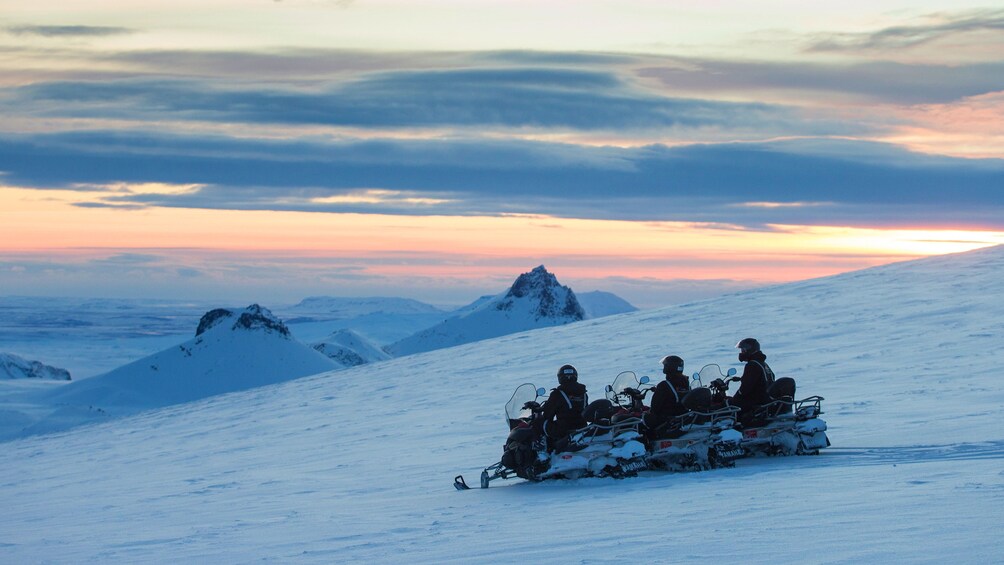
{"left": 454, "top": 383, "right": 646, "bottom": 490}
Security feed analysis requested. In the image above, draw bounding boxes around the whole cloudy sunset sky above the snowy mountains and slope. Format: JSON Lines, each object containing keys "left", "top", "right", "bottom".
{"left": 0, "top": 0, "right": 1004, "bottom": 307}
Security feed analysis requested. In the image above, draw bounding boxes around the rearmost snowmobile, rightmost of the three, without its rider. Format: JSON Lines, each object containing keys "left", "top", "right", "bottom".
{"left": 694, "top": 364, "right": 830, "bottom": 457}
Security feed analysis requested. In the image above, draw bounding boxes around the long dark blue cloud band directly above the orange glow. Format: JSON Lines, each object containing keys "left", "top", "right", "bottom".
{"left": 0, "top": 132, "right": 1004, "bottom": 228}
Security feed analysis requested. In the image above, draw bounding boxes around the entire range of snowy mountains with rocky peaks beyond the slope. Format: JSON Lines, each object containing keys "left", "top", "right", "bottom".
{"left": 0, "top": 265, "right": 636, "bottom": 439}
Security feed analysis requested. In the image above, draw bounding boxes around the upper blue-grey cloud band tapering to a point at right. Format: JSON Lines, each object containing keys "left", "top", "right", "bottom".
{"left": 8, "top": 69, "right": 831, "bottom": 134}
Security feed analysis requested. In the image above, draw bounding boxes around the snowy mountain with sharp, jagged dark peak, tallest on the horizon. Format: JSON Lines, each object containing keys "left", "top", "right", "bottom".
{"left": 387, "top": 265, "right": 586, "bottom": 356}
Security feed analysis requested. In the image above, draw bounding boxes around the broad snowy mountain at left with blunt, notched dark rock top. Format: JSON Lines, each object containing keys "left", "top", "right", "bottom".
{"left": 40, "top": 304, "right": 340, "bottom": 413}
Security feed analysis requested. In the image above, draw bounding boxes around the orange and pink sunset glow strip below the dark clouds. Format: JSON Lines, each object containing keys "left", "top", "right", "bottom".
{"left": 0, "top": 186, "right": 1004, "bottom": 283}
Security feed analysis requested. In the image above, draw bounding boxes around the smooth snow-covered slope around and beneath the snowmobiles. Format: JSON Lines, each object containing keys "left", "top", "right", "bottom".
{"left": 0, "top": 247, "right": 1004, "bottom": 563}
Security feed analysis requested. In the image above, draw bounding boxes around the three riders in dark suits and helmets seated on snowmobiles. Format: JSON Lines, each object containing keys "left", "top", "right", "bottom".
{"left": 534, "top": 337, "right": 774, "bottom": 453}
